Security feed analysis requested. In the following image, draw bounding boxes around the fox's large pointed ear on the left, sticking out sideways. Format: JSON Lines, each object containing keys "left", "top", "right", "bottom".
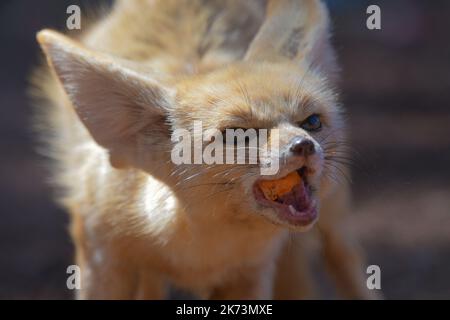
{"left": 37, "top": 30, "right": 174, "bottom": 167}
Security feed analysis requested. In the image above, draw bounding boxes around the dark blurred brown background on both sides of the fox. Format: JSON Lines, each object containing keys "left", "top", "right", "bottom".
{"left": 0, "top": 0, "right": 450, "bottom": 299}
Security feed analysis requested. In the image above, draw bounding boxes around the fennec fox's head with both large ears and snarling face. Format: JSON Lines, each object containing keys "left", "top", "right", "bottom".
{"left": 38, "top": 1, "right": 345, "bottom": 230}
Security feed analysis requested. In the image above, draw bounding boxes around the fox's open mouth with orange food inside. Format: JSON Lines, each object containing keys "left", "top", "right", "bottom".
{"left": 253, "top": 167, "right": 318, "bottom": 227}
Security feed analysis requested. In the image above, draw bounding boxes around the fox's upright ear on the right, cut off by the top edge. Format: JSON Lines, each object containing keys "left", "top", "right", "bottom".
{"left": 245, "top": 0, "right": 333, "bottom": 72}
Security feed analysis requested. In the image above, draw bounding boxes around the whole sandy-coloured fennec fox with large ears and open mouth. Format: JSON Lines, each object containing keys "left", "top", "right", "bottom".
{"left": 36, "top": 0, "right": 370, "bottom": 299}
